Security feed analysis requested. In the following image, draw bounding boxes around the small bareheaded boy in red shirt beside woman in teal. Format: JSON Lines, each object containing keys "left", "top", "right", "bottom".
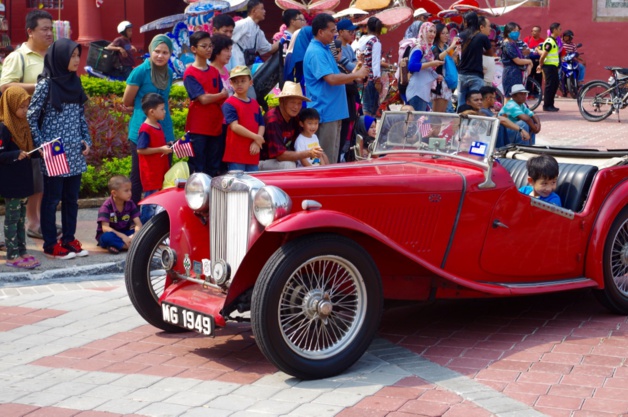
{"left": 137, "top": 93, "right": 172, "bottom": 224}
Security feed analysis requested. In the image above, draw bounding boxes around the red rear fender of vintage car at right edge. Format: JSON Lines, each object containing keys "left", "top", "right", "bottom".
{"left": 585, "top": 181, "right": 628, "bottom": 282}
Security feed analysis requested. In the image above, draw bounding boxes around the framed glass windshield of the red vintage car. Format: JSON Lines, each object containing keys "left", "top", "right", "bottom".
{"left": 372, "top": 111, "right": 499, "bottom": 166}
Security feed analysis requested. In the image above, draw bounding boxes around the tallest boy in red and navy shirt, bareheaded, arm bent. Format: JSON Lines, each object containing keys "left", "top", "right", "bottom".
{"left": 183, "top": 31, "right": 229, "bottom": 177}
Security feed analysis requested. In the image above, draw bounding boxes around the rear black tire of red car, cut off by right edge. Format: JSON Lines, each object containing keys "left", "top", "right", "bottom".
{"left": 594, "top": 207, "right": 628, "bottom": 315}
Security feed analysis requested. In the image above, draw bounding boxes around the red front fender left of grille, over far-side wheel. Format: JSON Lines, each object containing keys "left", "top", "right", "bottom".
{"left": 140, "top": 187, "right": 209, "bottom": 264}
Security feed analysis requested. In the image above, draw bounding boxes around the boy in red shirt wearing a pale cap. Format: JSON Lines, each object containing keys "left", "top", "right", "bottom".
{"left": 222, "top": 65, "right": 264, "bottom": 172}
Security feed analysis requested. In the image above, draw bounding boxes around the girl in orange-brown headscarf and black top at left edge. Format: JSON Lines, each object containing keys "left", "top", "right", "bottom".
{"left": 0, "top": 86, "right": 39, "bottom": 269}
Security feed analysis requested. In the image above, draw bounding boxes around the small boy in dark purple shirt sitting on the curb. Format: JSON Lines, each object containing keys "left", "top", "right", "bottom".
{"left": 96, "top": 175, "right": 142, "bottom": 253}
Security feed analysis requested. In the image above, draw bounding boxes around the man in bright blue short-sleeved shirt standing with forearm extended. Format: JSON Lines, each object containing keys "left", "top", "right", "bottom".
{"left": 303, "top": 13, "right": 368, "bottom": 163}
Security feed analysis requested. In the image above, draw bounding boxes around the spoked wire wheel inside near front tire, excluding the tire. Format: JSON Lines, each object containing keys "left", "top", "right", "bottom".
{"left": 278, "top": 256, "right": 368, "bottom": 359}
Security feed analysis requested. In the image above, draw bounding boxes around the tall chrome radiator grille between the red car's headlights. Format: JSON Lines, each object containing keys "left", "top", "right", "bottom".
{"left": 209, "top": 186, "right": 251, "bottom": 277}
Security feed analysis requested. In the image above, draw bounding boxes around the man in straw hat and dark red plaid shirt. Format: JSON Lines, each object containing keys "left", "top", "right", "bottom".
{"left": 259, "top": 81, "right": 323, "bottom": 171}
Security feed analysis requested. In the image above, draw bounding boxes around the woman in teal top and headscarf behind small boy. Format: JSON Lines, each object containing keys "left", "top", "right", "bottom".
{"left": 123, "top": 35, "right": 175, "bottom": 204}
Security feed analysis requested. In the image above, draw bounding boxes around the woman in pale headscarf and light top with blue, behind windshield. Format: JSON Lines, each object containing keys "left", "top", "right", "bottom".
{"left": 406, "top": 22, "right": 443, "bottom": 111}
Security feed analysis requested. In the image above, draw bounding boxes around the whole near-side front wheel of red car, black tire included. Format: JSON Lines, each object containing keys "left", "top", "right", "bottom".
{"left": 251, "top": 234, "right": 383, "bottom": 379}
